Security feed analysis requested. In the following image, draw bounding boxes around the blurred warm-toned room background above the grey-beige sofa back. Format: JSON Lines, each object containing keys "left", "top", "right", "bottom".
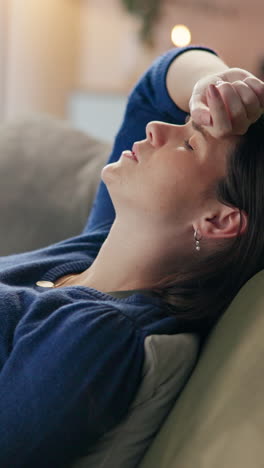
{"left": 0, "top": 0, "right": 264, "bottom": 141}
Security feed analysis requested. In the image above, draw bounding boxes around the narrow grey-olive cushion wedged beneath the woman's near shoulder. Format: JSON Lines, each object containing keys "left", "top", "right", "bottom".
{"left": 73, "top": 334, "right": 199, "bottom": 468}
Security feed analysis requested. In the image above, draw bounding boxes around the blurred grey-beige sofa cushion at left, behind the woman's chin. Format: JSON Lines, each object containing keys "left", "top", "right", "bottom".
{"left": 0, "top": 114, "right": 111, "bottom": 255}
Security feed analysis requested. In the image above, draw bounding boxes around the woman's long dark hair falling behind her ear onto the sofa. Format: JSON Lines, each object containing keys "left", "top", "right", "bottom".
{"left": 152, "top": 115, "right": 264, "bottom": 327}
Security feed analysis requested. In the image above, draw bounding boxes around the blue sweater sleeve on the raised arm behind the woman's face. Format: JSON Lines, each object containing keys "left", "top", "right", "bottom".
{"left": 83, "top": 46, "right": 215, "bottom": 233}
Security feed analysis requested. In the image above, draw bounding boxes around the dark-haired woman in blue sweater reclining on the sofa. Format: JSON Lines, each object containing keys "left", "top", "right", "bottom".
{"left": 0, "top": 47, "right": 264, "bottom": 468}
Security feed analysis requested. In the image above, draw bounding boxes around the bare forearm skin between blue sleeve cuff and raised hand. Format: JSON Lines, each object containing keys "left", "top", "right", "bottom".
{"left": 166, "top": 49, "right": 229, "bottom": 112}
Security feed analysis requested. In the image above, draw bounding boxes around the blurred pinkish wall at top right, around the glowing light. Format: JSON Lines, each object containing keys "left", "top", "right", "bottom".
{"left": 156, "top": 0, "right": 264, "bottom": 73}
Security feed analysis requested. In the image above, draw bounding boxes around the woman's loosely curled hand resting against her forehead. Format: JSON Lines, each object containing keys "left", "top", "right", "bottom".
{"left": 189, "top": 68, "right": 264, "bottom": 138}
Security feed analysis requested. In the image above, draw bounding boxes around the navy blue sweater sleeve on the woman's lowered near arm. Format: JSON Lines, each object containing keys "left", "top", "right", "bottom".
{"left": 0, "top": 293, "right": 144, "bottom": 468}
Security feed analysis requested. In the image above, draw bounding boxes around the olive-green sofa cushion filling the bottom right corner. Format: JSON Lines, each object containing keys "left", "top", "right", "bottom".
{"left": 139, "top": 271, "right": 264, "bottom": 468}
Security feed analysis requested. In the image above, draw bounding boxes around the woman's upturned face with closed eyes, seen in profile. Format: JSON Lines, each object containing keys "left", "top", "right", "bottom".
{"left": 102, "top": 120, "right": 238, "bottom": 222}
